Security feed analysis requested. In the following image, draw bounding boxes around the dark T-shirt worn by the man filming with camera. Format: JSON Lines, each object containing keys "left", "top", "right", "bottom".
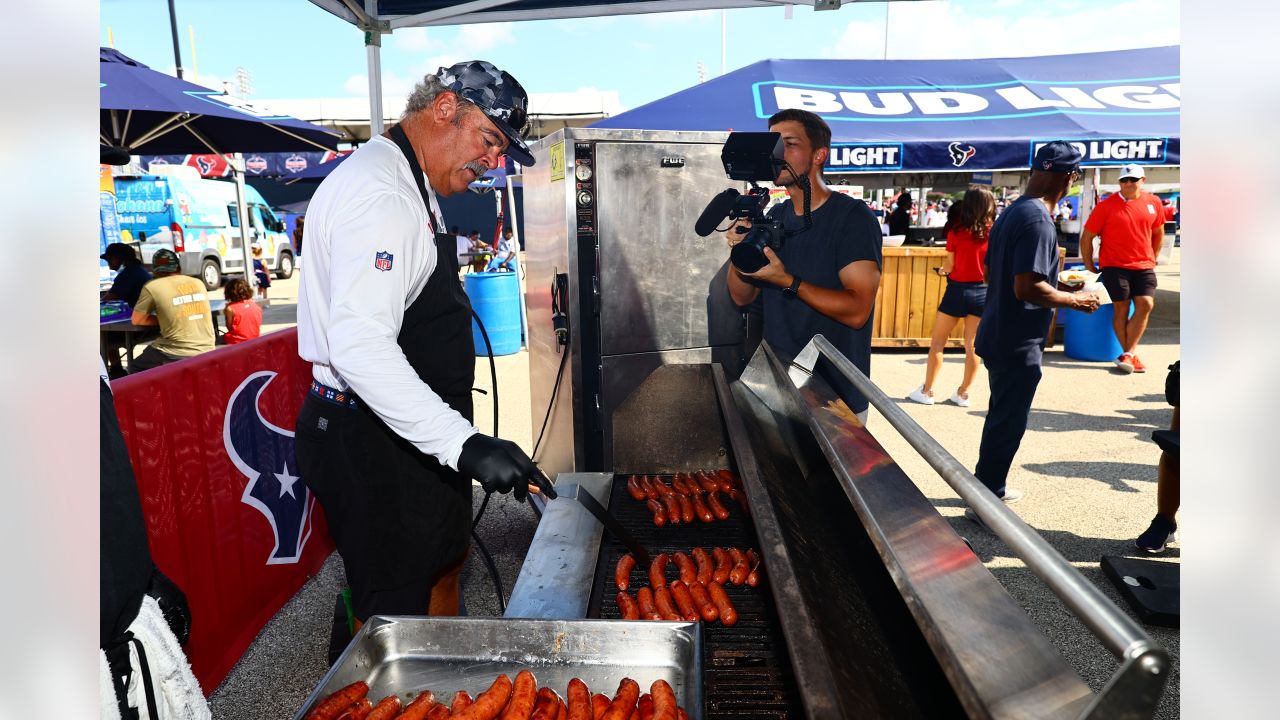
{"left": 762, "top": 192, "right": 882, "bottom": 413}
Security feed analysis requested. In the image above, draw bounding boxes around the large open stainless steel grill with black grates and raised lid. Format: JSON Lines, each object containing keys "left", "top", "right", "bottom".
{"left": 508, "top": 341, "right": 1164, "bottom": 720}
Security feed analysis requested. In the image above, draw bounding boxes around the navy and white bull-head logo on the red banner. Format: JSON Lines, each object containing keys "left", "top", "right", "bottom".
{"left": 223, "top": 370, "right": 316, "bottom": 565}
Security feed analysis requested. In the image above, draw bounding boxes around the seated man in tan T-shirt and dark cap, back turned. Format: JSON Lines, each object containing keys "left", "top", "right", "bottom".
{"left": 129, "top": 247, "right": 214, "bottom": 373}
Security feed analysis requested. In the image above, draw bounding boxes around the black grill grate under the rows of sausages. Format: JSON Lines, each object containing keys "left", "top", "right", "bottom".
{"left": 588, "top": 475, "right": 804, "bottom": 720}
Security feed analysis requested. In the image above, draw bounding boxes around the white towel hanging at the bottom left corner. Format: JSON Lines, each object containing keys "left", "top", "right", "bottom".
{"left": 128, "top": 596, "right": 210, "bottom": 720}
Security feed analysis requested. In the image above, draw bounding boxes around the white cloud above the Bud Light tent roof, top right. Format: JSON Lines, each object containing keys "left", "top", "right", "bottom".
{"left": 822, "top": 0, "right": 1179, "bottom": 59}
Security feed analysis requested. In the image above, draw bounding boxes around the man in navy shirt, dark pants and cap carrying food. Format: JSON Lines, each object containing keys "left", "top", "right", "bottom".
{"left": 965, "top": 141, "right": 1098, "bottom": 512}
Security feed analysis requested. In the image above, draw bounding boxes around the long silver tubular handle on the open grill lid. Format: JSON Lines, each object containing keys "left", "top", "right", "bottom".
{"left": 794, "top": 334, "right": 1169, "bottom": 720}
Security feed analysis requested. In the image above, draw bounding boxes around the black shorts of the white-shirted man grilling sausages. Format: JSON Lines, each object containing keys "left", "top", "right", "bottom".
{"left": 294, "top": 395, "right": 471, "bottom": 620}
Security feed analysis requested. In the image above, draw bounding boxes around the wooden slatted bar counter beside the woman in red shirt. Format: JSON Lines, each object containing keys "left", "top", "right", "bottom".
{"left": 872, "top": 247, "right": 964, "bottom": 347}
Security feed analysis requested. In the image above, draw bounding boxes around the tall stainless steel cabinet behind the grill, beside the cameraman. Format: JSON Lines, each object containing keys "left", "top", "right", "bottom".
{"left": 525, "top": 128, "right": 758, "bottom": 475}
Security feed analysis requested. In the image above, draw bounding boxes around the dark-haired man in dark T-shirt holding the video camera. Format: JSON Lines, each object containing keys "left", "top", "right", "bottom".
{"left": 726, "top": 109, "right": 881, "bottom": 423}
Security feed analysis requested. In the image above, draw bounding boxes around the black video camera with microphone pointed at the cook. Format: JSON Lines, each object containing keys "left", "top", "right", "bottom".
{"left": 694, "top": 132, "right": 813, "bottom": 273}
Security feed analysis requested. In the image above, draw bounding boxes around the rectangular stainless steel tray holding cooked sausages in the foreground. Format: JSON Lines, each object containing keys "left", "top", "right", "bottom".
{"left": 293, "top": 615, "right": 703, "bottom": 720}
